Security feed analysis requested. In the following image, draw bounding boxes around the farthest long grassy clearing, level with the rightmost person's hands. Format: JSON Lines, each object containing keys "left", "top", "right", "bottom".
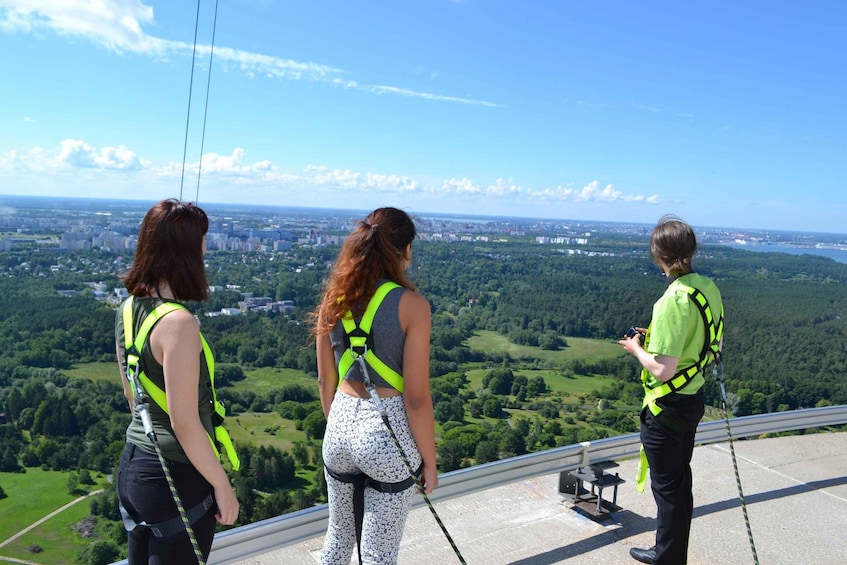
{"left": 467, "top": 330, "right": 623, "bottom": 363}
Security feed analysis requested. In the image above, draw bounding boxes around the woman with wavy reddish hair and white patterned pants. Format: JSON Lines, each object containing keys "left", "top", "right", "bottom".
{"left": 313, "top": 208, "right": 438, "bottom": 565}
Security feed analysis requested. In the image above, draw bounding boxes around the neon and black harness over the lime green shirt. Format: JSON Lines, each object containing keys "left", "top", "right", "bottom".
{"left": 635, "top": 283, "right": 723, "bottom": 492}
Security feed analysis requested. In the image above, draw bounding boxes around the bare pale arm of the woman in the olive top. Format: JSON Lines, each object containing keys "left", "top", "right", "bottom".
{"left": 150, "top": 310, "right": 238, "bottom": 524}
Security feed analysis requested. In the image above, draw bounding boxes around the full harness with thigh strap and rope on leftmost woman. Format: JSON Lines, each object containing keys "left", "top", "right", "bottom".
{"left": 119, "top": 296, "right": 241, "bottom": 548}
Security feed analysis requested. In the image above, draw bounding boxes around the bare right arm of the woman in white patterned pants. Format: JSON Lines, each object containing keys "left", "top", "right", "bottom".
{"left": 399, "top": 292, "right": 438, "bottom": 493}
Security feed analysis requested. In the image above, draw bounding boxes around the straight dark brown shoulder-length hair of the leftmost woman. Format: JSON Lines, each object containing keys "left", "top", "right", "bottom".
{"left": 123, "top": 198, "right": 209, "bottom": 301}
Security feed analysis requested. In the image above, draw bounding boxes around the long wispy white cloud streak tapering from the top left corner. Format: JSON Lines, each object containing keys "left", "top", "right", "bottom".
{"left": 0, "top": 0, "right": 500, "bottom": 108}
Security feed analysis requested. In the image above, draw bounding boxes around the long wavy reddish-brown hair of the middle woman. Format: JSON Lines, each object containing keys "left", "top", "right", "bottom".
{"left": 312, "top": 208, "right": 417, "bottom": 335}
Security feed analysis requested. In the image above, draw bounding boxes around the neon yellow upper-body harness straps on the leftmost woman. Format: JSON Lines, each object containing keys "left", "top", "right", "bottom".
{"left": 122, "top": 296, "right": 241, "bottom": 471}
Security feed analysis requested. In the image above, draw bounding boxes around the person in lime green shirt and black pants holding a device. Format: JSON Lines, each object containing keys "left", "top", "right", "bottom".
{"left": 618, "top": 216, "right": 723, "bottom": 565}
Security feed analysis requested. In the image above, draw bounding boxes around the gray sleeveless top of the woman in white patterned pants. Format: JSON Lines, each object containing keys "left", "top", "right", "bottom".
{"left": 329, "top": 279, "right": 407, "bottom": 388}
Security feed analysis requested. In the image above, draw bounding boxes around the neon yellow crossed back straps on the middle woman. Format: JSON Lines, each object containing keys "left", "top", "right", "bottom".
{"left": 338, "top": 281, "right": 403, "bottom": 392}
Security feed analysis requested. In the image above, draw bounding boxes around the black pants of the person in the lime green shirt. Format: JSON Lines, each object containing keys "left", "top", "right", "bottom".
{"left": 641, "top": 393, "right": 704, "bottom": 565}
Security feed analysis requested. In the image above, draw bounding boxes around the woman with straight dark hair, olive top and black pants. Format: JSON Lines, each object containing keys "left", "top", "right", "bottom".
{"left": 115, "top": 199, "right": 238, "bottom": 565}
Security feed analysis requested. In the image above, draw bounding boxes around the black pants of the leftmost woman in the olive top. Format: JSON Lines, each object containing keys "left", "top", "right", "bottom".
{"left": 117, "top": 443, "right": 216, "bottom": 565}
